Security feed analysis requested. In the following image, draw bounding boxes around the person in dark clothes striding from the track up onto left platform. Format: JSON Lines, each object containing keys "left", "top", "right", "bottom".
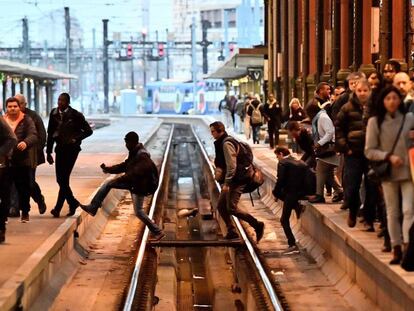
{"left": 81, "top": 132, "right": 165, "bottom": 240}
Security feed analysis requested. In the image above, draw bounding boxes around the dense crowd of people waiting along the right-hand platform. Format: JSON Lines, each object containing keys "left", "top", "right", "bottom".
{"left": 269, "top": 61, "right": 414, "bottom": 269}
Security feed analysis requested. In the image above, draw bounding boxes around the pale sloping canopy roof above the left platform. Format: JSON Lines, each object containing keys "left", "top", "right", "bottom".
{"left": 0, "top": 59, "right": 78, "bottom": 80}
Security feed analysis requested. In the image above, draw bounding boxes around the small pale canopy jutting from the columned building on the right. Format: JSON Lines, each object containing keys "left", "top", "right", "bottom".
{"left": 207, "top": 54, "right": 264, "bottom": 80}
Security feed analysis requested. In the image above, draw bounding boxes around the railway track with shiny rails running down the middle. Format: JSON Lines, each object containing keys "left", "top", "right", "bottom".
{"left": 123, "top": 125, "right": 288, "bottom": 311}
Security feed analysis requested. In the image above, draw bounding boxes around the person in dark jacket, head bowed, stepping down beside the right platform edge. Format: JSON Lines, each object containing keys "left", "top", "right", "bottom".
{"left": 273, "top": 147, "right": 307, "bottom": 252}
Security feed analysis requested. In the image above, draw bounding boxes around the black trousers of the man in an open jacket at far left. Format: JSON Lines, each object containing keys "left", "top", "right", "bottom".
{"left": 10, "top": 166, "right": 31, "bottom": 214}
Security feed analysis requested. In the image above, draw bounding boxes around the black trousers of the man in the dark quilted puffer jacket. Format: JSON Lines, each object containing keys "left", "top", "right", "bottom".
{"left": 343, "top": 155, "right": 378, "bottom": 225}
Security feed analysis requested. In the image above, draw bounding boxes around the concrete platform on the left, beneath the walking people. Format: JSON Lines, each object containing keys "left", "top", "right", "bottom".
{"left": 0, "top": 118, "right": 161, "bottom": 310}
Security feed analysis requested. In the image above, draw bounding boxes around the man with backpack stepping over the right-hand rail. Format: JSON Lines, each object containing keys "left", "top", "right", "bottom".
{"left": 210, "top": 121, "right": 264, "bottom": 242}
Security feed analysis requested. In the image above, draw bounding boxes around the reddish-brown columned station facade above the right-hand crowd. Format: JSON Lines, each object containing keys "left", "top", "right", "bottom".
{"left": 264, "top": 0, "right": 413, "bottom": 108}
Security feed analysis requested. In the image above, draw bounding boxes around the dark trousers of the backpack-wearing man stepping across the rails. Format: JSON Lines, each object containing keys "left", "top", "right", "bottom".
{"left": 217, "top": 185, "right": 258, "bottom": 232}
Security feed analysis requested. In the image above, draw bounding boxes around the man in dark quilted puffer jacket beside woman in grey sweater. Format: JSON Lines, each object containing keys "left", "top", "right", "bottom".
{"left": 335, "top": 80, "right": 376, "bottom": 231}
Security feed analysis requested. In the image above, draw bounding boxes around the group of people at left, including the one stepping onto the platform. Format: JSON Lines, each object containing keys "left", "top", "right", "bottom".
{"left": 0, "top": 93, "right": 164, "bottom": 243}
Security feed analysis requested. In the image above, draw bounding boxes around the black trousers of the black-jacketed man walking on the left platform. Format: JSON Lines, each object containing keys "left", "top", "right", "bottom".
{"left": 54, "top": 147, "right": 80, "bottom": 212}
